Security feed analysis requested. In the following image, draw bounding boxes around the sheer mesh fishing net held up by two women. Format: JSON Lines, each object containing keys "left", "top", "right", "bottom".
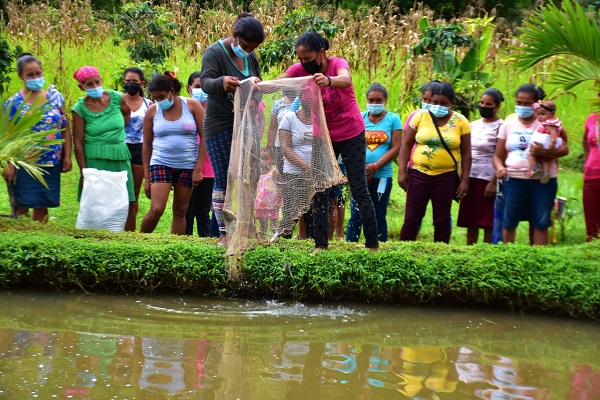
{"left": 223, "top": 77, "right": 346, "bottom": 254}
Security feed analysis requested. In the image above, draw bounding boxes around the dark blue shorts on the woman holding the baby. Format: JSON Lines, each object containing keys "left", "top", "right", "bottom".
{"left": 502, "top": 178, "right": 558, "bottom": 230}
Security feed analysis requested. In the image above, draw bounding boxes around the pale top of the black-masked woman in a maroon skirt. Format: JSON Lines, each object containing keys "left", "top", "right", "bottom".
{"left": 470, "top": 118, "right": 504, "bottom": 181}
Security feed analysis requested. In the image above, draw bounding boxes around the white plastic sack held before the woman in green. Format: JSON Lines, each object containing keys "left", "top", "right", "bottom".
{"left": 75, "top": 168, "right": 129, "bottom": 232}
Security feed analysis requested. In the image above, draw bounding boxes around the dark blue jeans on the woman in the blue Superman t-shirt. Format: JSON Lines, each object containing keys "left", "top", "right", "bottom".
{"left": 346, "top": 178, "right": 392, "bottom": 242}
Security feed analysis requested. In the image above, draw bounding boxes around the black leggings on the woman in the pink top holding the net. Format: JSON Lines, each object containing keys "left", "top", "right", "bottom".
{"left": 313, "top": 131, "right": 379, "bottom": 248}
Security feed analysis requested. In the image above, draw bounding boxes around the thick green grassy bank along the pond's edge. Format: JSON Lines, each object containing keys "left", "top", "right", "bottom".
{"left": 0, "top": 218, "right": 600, "bottom": 318}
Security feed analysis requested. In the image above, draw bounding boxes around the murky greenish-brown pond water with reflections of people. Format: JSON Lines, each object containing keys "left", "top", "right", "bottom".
{"left": 0, "top": 291, "right": 600, "bottom": 400}
